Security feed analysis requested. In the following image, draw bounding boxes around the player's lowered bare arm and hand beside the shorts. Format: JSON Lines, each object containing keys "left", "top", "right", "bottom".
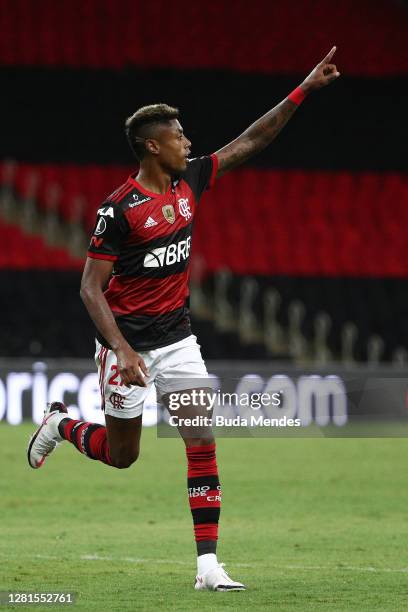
{"left": 80, "top": 257, "right": 149, "bottom": 387}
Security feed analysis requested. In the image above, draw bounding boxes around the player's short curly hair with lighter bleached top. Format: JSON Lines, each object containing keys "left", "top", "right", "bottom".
{"left": 125, "top": 104, "right": 180, "bottom": 161}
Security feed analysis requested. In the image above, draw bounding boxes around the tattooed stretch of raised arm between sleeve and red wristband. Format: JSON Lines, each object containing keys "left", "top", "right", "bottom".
{"left": 216, "top": 99, "right": 297, "bottom": 176}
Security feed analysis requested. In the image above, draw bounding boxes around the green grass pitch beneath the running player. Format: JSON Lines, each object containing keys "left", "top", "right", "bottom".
{"left": 0, "top": 424, "right": 408, "bottom": 612}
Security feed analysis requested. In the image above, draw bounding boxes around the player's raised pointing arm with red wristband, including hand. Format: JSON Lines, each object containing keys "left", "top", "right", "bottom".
{"left": 216, "top": 47, "right": 340, "bottom": 177}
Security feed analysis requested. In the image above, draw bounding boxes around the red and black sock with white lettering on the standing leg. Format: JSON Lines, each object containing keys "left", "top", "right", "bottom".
{"left": 186, "top": 443, "right": 221, "bottom": 555}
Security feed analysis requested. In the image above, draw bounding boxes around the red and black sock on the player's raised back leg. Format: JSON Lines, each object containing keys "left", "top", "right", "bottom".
{"left": 59, "top": 419, "right": 112, "bottom": 465}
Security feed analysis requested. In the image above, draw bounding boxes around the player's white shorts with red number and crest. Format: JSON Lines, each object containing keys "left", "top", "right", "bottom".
{"left": 95, "top": 335, "right": 208, "bottom": 419}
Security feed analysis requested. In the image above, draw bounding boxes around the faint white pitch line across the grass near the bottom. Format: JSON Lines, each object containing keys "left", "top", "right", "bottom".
{"left": 27, "top": 554, "right": 408, "bottom": 574}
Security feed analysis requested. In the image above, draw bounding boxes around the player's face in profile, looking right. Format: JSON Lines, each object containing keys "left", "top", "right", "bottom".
{"left": 157, "top": 119, "right": 191, "bottom": 174}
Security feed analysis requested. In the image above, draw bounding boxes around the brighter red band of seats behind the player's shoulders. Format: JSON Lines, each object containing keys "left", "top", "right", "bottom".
{"left": 2, "top": 164, "right": 408, "bottom": 276}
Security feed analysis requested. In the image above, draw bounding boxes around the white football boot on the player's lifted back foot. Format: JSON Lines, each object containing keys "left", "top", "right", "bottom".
{"left": 27, "top": 402, "right": 68, "bottom": 469}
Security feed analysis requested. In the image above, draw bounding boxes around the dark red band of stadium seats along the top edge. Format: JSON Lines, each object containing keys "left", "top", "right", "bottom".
{"left": 0, "top": 0, "right": 408, "bottom": 76}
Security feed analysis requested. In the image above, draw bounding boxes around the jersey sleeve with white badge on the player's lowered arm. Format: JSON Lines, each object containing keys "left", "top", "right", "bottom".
{"left": 88, "top": 203, "right": 129, "bottom": 261}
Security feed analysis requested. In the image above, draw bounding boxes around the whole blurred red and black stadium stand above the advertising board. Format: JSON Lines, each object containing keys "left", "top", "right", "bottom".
{"left": 0, "top": 0, "right": 408, "bottom": 365}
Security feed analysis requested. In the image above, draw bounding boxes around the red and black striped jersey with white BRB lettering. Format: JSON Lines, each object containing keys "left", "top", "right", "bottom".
{"left": 88, "top": 154, "right": 218, "bottom": 351}
